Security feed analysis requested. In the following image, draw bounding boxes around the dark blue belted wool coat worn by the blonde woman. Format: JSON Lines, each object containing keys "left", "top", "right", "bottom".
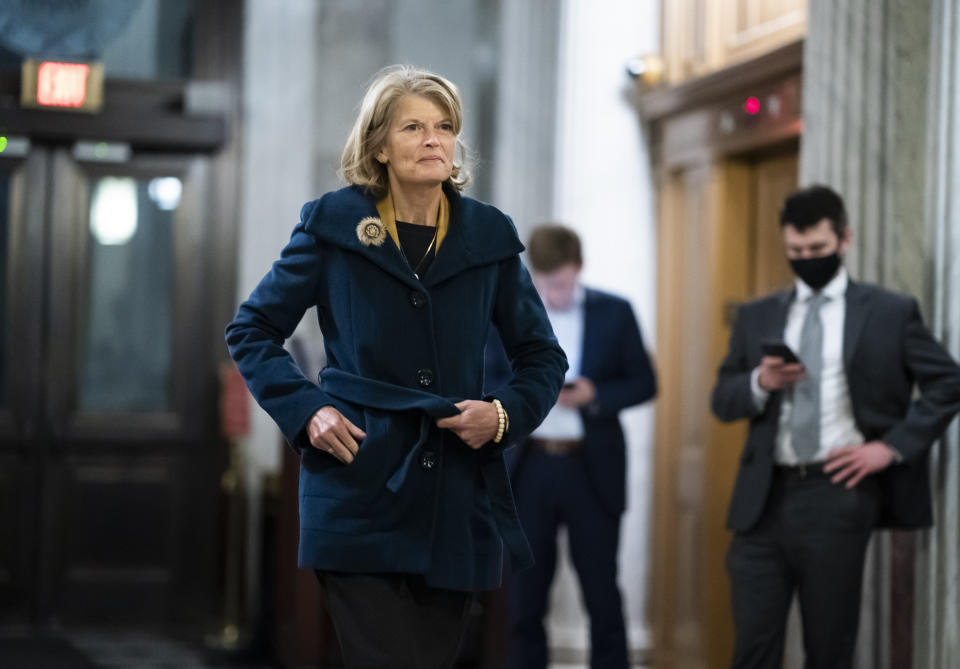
{"left": 226, "top": 186, "right": 567, "bottom": 590}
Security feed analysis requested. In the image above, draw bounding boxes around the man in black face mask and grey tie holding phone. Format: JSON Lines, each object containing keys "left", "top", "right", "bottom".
{"left": 713, "top": 186, "right": 960, "bottom": 669}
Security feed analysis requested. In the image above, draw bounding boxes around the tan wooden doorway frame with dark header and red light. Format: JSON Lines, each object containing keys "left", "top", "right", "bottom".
{"left": 638, "top": 37, "right": 803, "bottom": 669}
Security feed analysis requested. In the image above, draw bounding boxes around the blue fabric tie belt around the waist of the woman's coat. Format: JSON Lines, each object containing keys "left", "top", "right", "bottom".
{"left": 320, "top": 367, "right": 533, "bottom": 571}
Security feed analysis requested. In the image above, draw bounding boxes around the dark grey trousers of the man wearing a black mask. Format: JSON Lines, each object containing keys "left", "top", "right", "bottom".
{"left": 727, "top": 468, "right": 879, "bottom": 669}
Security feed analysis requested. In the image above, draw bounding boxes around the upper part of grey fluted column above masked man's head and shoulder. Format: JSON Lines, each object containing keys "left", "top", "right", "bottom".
{"left": 800, "top": 0, "right": 929, "bottom": 294}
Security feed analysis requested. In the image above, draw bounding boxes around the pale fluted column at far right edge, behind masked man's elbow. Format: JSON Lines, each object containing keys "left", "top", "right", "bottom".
{"left": 913, "top": 0, "right": 960, "bottom": 669}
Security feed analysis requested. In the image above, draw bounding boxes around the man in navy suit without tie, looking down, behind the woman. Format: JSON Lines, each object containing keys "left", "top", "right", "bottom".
{"left": 485, "top": 225, "right": 656, "bottom": 669}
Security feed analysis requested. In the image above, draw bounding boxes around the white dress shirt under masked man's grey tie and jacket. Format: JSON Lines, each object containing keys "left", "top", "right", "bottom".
{"left": 750, "top": 268, "right": 863, "bottom": 465}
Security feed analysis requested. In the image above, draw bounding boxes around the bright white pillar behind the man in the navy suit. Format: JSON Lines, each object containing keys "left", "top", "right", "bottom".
{"left": 540, "top": 0, "right": 659, "bottom": 657}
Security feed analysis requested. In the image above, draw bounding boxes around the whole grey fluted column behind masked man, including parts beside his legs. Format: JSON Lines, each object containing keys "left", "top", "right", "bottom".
{"left": 800, "top": 0, "right": 931, "bottom": 669}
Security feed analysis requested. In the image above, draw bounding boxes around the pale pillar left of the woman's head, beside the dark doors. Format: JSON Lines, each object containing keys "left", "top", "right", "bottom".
{"left": 237, "top": 0, "right": 317, "bottom": 620}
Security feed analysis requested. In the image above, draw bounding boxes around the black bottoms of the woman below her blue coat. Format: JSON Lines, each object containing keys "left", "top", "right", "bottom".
{"left": 316, "top": 571, "right": 473, "bottom": 669}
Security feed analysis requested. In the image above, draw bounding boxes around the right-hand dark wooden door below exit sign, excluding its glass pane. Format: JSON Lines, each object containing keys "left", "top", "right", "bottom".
{"left": 37, "top": 153, "right": 220, "bottom": 624}
